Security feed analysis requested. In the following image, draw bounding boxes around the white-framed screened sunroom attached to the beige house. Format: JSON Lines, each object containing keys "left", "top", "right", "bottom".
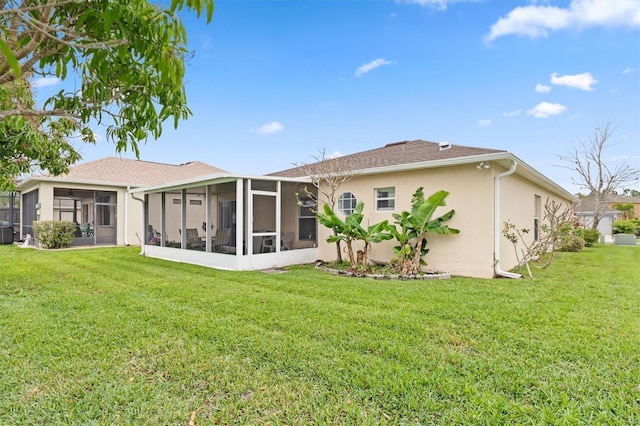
{"left": 130, "top": 174, "right": 318, "bottom": 270}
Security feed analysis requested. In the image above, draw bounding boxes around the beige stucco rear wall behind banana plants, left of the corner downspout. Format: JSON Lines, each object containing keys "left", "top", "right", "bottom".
{"left": 318, "top": 165, "right": 493, "bottom": 277}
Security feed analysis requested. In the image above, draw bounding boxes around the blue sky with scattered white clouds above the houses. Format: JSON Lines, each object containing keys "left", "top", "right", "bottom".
{"left": 33, "top": 0, "right": 640, "bottom": 192}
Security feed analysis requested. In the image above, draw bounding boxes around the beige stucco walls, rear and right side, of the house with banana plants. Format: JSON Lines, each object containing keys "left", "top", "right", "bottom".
{"left": 318, "top": 164, "right": 572, "bottom": 278}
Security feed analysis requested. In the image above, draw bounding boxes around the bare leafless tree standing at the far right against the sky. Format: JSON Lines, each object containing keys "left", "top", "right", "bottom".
{"left": 560, "top": 123, "right": 640, "bottom": 229}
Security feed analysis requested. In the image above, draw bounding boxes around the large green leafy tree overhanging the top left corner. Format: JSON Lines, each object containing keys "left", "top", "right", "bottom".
{"left": 0, "top": 0, "right": 213, "bottom": 189}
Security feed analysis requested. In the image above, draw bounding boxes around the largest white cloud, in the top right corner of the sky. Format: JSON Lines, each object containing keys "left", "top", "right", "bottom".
{"left": 486, "top": 0, "right": 640, "bottom": 41}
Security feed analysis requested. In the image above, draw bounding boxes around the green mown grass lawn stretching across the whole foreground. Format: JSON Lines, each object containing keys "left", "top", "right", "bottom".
{"left": 0, "top": 246, "right": 640, "bottom": 425}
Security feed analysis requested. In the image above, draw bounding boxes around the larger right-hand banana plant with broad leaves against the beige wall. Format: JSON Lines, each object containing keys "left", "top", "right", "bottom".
{"left": 391, "top": 187, "right": 460, "bottom": 275}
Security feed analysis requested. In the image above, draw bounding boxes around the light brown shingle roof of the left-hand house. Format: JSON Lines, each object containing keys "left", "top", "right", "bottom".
{"left": 52, "top": 157, "right": 226, "bottom": 186}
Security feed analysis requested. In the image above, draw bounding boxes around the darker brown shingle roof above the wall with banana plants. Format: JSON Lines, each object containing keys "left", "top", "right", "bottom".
{"left": 268, "top": 140, "right": 506, "bottom": 177}
